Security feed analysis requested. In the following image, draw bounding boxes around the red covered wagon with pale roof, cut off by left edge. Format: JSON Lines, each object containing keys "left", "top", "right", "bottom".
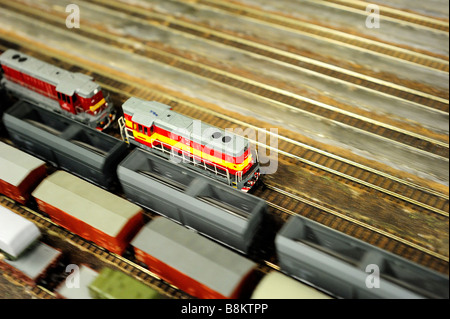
{"left": 0, "top": 142, "right": 47, "bottom": 204}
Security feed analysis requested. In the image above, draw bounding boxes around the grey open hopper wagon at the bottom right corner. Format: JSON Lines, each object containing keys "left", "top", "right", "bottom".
{"left": 275, "top": 216, "right": 449, "bottom": 299}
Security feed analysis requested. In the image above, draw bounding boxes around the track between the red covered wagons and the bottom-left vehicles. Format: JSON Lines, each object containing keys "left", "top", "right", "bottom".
{"left": 0, "top": 196, "right": 192, "bottom": 299}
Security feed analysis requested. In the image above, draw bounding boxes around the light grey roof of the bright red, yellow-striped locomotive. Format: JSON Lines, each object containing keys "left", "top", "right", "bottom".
{"left": 122, "top": 97, "right": 248, "bottom": 156}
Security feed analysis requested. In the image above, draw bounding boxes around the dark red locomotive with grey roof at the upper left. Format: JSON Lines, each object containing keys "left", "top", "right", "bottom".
{"left": 0, "top": 49, "right": 116, "bottom": 130}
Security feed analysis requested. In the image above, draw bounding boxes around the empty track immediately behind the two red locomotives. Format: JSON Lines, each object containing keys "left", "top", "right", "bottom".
{"left": 0, "top": 42, "right": 449, "bottom": 222}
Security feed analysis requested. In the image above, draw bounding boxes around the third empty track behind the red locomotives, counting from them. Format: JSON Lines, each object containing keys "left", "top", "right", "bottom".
{"left": 89, "top": 0, "right": 449, "bottom": 112}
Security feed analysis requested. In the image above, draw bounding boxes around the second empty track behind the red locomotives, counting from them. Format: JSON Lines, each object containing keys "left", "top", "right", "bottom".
{"left": 2, "top": 5, "right": 449, "bottom": 159}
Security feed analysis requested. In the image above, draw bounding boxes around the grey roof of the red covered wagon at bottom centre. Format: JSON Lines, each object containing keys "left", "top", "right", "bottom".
{"left": 132, "top": 217, "right": 256, "bottom": 296}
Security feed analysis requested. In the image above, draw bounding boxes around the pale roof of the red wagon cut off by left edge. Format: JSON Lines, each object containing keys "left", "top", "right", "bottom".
{"left": 0, "top": 142, "right": 45, "bottom": 186}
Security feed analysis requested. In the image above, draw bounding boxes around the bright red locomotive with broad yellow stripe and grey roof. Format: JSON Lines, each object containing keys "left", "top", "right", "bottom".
{"left": 119, "top": 97, "right": 260, "bottom": 191}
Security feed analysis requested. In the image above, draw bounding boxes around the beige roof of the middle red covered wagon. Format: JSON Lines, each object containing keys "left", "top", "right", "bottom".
{"left": 32, "top": 171, "right": 141, "bottom": 237}
